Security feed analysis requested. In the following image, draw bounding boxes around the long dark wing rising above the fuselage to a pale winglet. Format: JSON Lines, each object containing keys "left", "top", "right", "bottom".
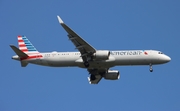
{"left": 57, "top": 16, "right": 96, "bottom": 62}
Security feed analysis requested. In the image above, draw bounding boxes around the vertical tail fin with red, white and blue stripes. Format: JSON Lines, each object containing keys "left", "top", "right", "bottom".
{"left": 18, "top": 36, "right": 39, "bottom": 54}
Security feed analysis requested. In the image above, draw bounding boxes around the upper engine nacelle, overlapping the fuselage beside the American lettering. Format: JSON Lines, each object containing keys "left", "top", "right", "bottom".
{"left": 93, "top": 50, "right": 110, "bottom": 60}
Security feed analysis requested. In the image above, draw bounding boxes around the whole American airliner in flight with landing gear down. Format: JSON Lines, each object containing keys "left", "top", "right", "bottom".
{"left": 10, "top": 16, "right": 171, "bottom": 84}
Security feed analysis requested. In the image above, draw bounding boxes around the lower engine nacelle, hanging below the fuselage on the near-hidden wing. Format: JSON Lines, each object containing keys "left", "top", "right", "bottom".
{"left": 104, "top": 70, "right": 120, "bottom": 80}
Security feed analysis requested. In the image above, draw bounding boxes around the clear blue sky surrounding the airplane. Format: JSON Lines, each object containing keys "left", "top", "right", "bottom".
{"left": 0, "top": 0, "right": 180, "bottom": 111}
